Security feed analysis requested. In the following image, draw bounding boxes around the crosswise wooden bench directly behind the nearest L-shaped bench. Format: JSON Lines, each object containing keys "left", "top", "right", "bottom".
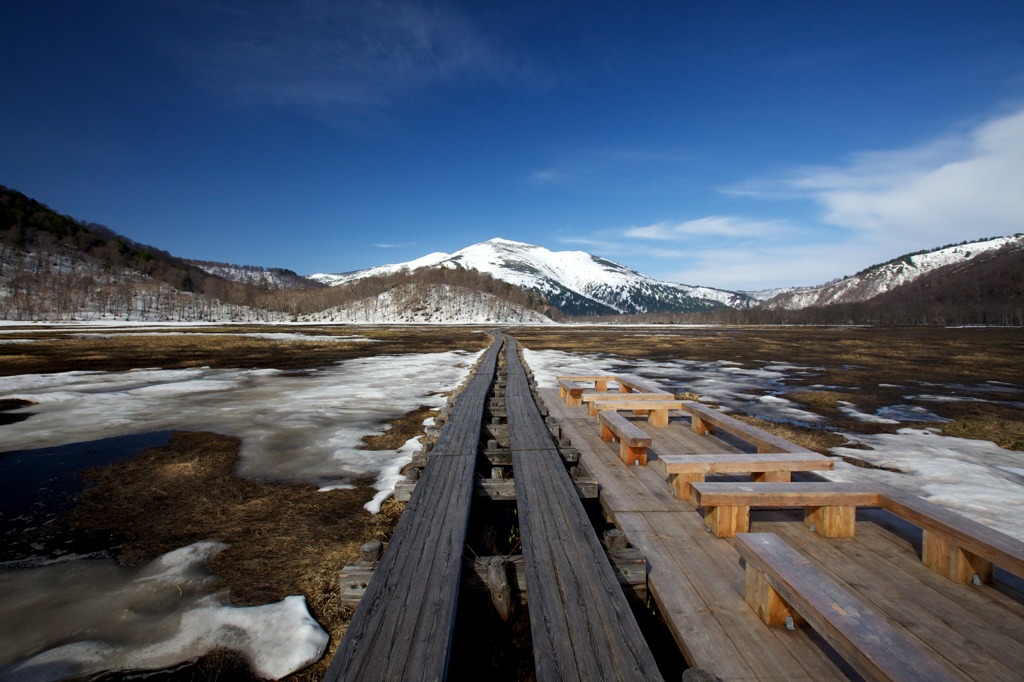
{"left": 658, "top": 453, "right": 836, "bottom": 502}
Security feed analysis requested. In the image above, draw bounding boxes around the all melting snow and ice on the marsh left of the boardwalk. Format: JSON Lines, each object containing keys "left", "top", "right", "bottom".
{"left": 0, "top": 346, "right": 477, "bottom": 680}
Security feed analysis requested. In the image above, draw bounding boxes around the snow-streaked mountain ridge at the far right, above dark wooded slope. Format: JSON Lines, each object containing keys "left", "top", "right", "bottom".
{"left": 761, "top": 235, "right": 1024, "bottom": 310}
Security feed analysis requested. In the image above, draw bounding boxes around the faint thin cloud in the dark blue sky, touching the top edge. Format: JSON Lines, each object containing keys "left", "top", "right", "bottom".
{"left": 178, "top": 0, "right": 520, "bottom": 110}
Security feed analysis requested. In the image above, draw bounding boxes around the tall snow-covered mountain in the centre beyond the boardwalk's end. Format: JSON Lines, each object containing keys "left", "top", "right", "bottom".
{"left": 309, "top": 239, "right": 754, "bottom": 315}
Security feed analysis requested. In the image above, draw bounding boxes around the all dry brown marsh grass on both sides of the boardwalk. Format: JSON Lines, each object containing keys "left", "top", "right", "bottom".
{"left": 8, "top": 327, "right": 1024, "bottom": 680}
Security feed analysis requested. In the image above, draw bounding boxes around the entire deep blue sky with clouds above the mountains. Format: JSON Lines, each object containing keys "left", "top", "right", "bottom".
{"left": 0, "top": 0, "right": 1024, "bottom": 289}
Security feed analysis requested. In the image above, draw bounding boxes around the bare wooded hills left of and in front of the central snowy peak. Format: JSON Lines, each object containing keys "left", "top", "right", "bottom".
{"left": 0, "top": 185, "right": 558, "bottom": 322}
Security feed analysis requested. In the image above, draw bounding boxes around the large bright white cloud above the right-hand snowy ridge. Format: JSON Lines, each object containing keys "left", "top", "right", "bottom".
{"left": 603, "top": 104, "right": 1024, "bottom": 290}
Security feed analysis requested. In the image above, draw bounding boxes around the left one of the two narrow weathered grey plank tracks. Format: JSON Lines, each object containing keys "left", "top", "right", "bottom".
{"left": 324, "top": 338, "right": 503, "bottom": 681}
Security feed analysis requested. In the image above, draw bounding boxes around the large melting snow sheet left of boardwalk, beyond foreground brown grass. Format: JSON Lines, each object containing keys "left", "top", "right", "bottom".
{"left": 0, "top": 351, "right": 479, "bottom": 485}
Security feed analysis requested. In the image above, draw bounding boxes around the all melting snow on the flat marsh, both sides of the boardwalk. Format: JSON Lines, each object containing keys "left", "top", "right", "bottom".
{"left": 0, "top": 335, "right": 1024, "bottom": 680}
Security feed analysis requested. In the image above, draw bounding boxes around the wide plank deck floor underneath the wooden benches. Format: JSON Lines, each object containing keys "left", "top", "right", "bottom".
{"left": 541, "top": 389, "right": 1024, "bottom": 680}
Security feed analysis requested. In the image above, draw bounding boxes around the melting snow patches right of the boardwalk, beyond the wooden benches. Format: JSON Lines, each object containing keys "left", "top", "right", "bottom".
{"left": 523, "top": 349, "right": 1024, "bottom": 540}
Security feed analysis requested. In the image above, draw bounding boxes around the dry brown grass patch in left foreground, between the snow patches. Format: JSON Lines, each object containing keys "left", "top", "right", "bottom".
{"left": 69, "top": 421, "right": 422, "bottom": 680}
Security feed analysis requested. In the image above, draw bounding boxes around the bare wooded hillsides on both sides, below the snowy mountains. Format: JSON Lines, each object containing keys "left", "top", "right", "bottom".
{"left": 0, "top": 185, "right": 1024, "bottom": 326}
